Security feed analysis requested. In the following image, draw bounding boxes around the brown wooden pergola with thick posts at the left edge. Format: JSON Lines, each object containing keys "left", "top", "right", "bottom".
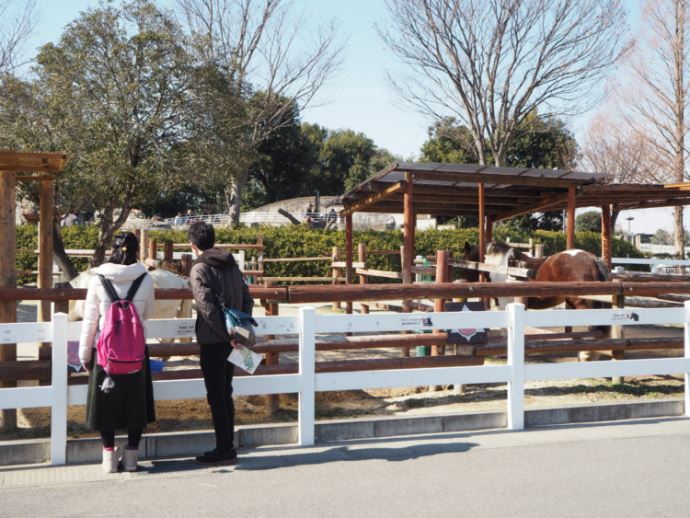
{"left": 0, "top": 151, "right": 67, "bottom": 429}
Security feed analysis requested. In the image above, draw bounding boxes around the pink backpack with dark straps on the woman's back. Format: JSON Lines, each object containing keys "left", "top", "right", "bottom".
{"left": 96, "top": 273, "right": 146, "bottom": 375}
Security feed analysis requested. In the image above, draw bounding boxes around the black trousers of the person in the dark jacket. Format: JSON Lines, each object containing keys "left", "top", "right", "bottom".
{"left": 200, "top": 343, "right": 235, "bottom": 451}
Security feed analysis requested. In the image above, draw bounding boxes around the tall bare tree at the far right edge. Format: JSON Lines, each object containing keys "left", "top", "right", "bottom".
{"left": 623, "top": 0, "right": 690, "bottom": 257}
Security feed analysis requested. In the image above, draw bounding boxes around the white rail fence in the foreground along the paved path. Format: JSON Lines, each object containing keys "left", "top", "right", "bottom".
{"left": 0, "top": 302, "right": 690, "bottom": 464}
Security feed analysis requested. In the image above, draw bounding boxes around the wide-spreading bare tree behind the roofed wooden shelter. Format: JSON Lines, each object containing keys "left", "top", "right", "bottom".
{"left": 379, "top": 0, "right": 626, "bottom": 165}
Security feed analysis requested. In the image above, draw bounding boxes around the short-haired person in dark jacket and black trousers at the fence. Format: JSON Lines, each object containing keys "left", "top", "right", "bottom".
{"left": 189, "top": 221, "right": 254, "bottom": 464}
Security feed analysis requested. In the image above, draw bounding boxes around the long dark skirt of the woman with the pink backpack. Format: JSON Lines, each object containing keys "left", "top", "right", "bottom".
{"left": 86, "top": 347, "right": 156, "bottom": 431}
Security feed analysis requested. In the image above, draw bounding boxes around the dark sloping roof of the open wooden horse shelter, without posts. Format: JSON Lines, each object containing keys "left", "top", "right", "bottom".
{"left": 342, "top": 162, "right": 690, "bottom": 221}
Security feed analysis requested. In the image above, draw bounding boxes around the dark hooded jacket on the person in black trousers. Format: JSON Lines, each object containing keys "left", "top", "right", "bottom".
{"left": 189, "top": 248, "right": 254, "bottom": 345}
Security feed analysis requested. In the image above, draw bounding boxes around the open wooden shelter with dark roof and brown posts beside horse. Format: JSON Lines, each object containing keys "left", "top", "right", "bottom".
{"left": 341, "top": 162, "right": 690, "bottom": 283}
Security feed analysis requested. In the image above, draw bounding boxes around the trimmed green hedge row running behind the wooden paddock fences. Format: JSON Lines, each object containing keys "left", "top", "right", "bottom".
{"left": 17, "top": 225, "right": 644, "bottom": 282}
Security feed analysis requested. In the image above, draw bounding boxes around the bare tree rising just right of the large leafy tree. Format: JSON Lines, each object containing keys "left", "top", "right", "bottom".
{"left": 179, "top": 0, "right": 341, "bottom": 223}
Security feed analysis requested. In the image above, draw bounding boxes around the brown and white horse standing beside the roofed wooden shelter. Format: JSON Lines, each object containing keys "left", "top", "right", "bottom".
{"left": 462, "top": 242, "right": 610, "bottom": 360}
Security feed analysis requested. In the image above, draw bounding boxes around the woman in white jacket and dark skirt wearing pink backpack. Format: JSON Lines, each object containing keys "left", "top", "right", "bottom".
{"left": 79, "top": 232, "right": 155, "bottom": 473}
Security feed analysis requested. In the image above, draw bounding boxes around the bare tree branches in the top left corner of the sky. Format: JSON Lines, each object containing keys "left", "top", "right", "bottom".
{"left": 0, "top": 0, "right": 36, "bottom": 74}
